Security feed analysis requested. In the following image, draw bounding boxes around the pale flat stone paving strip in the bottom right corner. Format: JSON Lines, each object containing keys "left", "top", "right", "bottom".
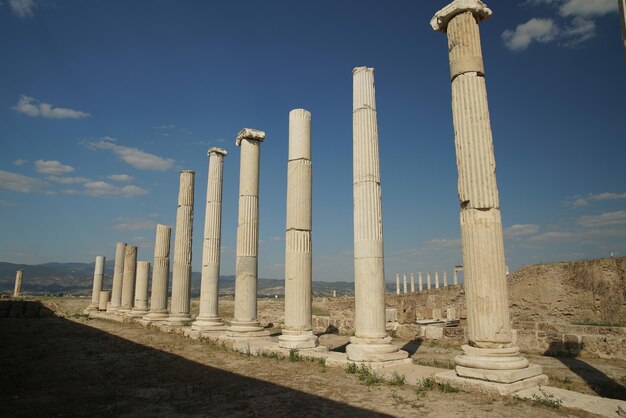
{"left": 514, "top": 386, "right": 626, "bottom": 418}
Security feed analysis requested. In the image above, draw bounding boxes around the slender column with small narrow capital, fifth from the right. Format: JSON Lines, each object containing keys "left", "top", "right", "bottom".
{"left": 191, "top": 148, "right": 227, "bottom": 331}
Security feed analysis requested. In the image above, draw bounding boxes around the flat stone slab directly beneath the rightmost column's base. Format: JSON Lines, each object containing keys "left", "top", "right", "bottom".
{"left": 435, "top": 370, "right": 548, "bottom": 396}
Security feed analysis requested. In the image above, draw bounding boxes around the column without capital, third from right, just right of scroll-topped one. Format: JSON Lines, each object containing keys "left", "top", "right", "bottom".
{"left": 278, "top": 109, "right": 318, "bottom": 349}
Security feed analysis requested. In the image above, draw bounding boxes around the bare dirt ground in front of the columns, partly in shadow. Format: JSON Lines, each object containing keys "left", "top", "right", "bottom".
{"left": 0, "top": 299, "right": 626, "bottom": 417}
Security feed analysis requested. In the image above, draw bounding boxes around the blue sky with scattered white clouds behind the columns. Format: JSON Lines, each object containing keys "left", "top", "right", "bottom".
{"left": 0, "top": 0, "right": 626, "bottom": 281}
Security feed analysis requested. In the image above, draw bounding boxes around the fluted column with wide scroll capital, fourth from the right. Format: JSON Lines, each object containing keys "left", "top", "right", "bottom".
{"left": 228, "top": 128, "right": 269, "bottom": 337}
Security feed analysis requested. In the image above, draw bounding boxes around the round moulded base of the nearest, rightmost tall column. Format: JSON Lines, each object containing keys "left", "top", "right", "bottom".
{"left": 454, "top": 345, "right": 543, "bottom": 383}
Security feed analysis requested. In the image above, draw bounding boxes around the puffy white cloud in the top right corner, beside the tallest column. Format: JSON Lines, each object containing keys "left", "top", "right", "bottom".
{"left": 502, "top": 0, "right": 618, "bottom": 52}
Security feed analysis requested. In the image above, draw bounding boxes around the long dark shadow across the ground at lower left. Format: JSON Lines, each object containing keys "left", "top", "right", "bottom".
{"left": 0, "top": 306, "right": 386, "bottom": 417}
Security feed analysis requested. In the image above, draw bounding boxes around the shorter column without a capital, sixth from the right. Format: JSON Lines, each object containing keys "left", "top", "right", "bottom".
{"left": 167, "top": 170, "right": 196, "bottom": 326}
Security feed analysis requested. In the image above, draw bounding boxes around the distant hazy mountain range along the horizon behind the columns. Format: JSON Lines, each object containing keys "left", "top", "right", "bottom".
{"left": 0, "top": 261, "right": 356, "bottom": 297}
